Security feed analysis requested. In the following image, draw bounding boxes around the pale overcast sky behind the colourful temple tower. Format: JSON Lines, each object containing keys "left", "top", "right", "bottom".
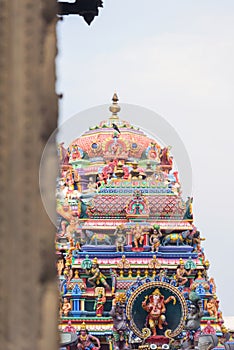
{"left": 57, "top": 0, "right": 234, "bottom": 316}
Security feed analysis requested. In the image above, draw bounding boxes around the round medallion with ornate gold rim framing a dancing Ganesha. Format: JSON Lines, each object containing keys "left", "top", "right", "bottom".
{"left": 126, "top": 281, "right": 187, "bottom": 338}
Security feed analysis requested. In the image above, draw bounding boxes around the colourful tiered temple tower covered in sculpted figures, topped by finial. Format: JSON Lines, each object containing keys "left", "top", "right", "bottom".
{"left": 56, "top": 94, "right": 230, "bottom": 350}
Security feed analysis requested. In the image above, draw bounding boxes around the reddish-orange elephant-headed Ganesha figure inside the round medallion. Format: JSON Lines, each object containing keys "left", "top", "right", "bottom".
{"left": 142, "top": 288, "right": 176, "bottom": 336}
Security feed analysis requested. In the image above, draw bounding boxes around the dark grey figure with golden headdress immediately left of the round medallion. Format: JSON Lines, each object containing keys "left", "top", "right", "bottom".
{"left": 110, "top": 293, "right": 129, "bottom": 350}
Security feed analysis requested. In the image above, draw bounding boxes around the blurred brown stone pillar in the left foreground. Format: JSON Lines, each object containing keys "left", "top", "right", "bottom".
{"left": 0, "top": 0, "right": 58, "bottom": 350}
